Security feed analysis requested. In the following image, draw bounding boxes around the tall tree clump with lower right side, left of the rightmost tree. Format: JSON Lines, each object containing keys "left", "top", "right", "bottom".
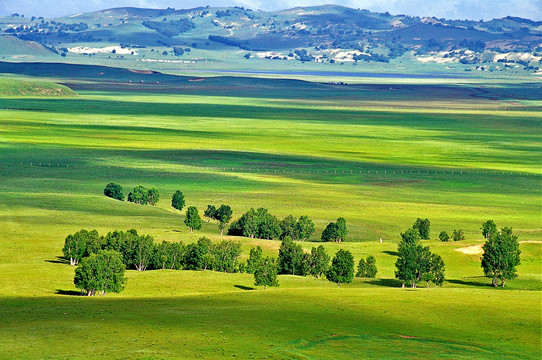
{"left": 395, "top": 228, "right": 444, "bottom": 288}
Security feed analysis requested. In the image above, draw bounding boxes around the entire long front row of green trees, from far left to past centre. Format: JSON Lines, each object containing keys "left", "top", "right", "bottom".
{"left": 62, "top": 229, "right": 377, "bottom": 296}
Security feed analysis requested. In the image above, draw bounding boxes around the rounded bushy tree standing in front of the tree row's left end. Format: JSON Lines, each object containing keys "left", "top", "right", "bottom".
{"left": 73, "top": 250, "right": 126, "bottom": 296}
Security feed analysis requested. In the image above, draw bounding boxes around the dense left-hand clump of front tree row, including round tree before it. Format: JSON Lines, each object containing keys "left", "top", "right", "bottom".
{"left": 62, "top": 229, "right": 241, "bottom": 295}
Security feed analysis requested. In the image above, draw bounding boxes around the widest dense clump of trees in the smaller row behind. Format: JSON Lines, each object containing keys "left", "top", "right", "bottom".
{"left": 228, "top": 208, "right": 314, "bottom": 241}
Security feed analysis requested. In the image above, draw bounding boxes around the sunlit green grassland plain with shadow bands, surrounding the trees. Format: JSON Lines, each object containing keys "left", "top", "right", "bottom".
{"left": 0, "top": 74, "right": 542, "bottom": 359}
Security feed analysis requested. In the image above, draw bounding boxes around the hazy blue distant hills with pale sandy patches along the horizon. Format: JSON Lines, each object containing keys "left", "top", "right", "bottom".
{"left": 0, "top": 5, "right": 542, "bottom": 73}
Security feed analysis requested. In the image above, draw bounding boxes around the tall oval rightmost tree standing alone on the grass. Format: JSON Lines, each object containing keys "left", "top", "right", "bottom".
{"left": 481, "top": 227, "right": 521, "bottom": 287}
